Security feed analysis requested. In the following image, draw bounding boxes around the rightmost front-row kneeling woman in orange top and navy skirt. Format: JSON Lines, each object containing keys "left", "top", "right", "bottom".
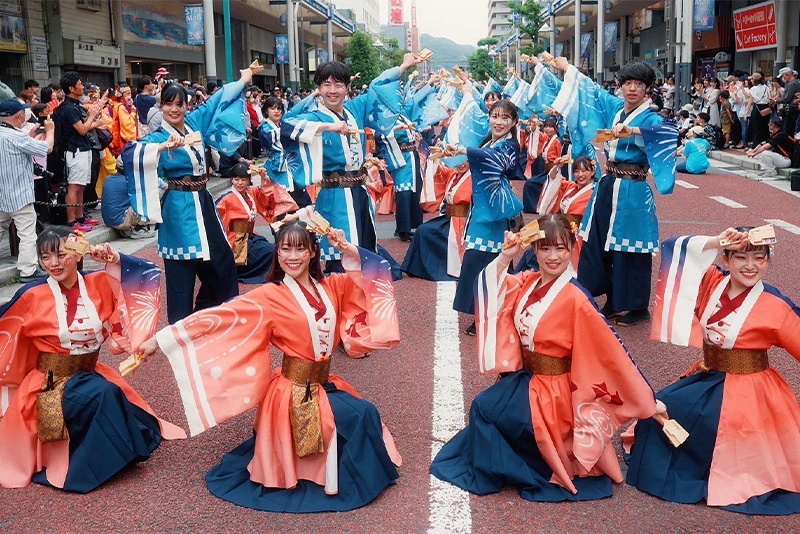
{"left": 628, "top": 228, "right": 800, "bottom": 515}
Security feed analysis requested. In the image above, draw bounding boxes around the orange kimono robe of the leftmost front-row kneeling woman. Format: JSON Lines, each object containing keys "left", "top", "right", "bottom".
{"left": 0, "top": 255, "right": 186, "bottom": 488}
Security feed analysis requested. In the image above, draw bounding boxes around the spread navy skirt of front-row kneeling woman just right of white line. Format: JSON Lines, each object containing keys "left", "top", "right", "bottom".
{"left": 431, "top": 370, "right": 612, "bottom": 502}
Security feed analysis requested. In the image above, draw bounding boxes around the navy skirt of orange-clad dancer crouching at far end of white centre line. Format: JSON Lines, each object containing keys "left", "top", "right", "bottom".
{"left": 402, "top": 215, "right": 455, "bottom": 282}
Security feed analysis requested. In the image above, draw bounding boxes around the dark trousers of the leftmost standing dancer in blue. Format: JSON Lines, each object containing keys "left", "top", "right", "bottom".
{"left": 164, "top": 204, "right": 239, "bottom": 324}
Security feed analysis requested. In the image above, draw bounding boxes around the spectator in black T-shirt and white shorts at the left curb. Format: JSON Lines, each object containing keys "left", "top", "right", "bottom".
{"left": 58, "top": 71, "right": 105, "bottom": 232}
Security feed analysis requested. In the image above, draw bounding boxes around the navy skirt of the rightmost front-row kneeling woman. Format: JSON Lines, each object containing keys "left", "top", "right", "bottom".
{"left": 626, "top": 371, "right": 800, "bottom": 515}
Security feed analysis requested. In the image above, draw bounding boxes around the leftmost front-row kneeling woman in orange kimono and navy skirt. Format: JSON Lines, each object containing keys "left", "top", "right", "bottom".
{"left": 0, "top": 226, "right": 186, "bottom": 493}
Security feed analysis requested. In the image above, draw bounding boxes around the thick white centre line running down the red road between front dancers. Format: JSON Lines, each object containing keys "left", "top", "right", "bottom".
{"left": 428, "top": 282, "right": 472, "bottom": 534}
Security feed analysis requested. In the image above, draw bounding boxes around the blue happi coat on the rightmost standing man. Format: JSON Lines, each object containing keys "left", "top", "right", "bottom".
{"left": 551, "top": 66, "right": 678, "bottom": 254}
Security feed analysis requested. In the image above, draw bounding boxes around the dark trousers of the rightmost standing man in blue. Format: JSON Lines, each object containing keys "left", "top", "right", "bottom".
{"left": 578, "top": 176, "right": 653, "bottom": 312}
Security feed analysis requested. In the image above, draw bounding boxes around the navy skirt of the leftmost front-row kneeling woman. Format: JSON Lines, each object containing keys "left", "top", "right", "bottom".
{"left": 33, "top": 373, "right": 161, "bottom": 493}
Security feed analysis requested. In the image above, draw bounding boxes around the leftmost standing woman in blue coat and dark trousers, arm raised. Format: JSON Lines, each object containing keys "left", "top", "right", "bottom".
{"left": 122, "top": 69, "right": 253, "bottom": 323}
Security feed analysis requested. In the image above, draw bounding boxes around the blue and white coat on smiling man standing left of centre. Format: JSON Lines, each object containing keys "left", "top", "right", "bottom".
{"left": 281, "top": 67, "right": 403, "bottom": 260}
